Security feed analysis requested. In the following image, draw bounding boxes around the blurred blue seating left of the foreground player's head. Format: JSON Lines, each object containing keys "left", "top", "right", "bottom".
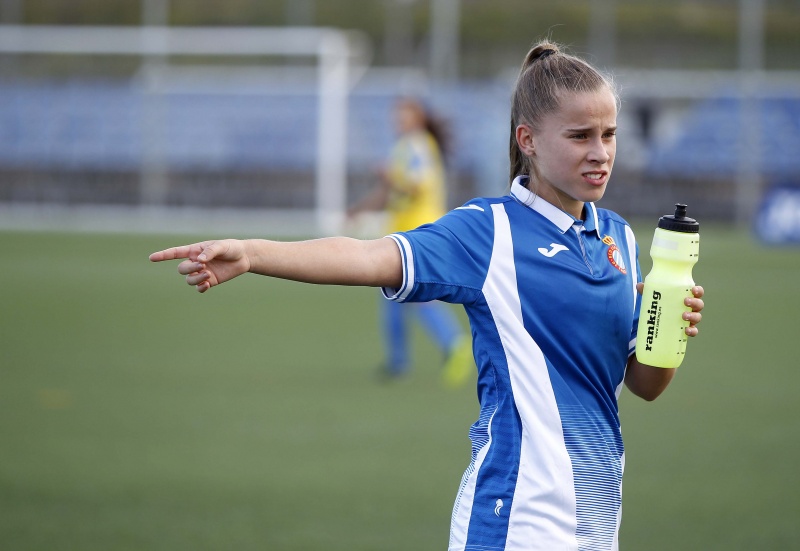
{"left": 0, "top": 81, "right": 507, "bottom": 180}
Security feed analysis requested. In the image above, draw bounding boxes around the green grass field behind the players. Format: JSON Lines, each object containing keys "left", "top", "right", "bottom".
{"left": 0, "top": 224, "right": 800, "bottom": 551}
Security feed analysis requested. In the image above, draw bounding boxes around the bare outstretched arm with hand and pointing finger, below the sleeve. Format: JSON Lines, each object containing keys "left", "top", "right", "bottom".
{"left": 150, "top": 237, "right": 403, "bottom": 293}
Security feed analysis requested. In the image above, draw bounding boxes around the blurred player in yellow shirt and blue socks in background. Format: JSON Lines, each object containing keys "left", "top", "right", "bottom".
{"left": 348, "top": 98, "right": 474, "bottom": 387}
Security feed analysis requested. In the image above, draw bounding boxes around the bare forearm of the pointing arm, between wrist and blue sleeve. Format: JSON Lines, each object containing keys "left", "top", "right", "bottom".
{"left": 245, "top": 237, "right": 403, "bottom": 287}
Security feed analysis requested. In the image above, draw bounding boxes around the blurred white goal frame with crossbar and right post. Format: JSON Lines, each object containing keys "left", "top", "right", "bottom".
{"left": 0, "top": 25, "right": 369, "bottom": 232}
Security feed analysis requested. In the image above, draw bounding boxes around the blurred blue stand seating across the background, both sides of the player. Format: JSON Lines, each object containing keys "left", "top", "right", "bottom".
{"left": 6, "top": 79, "right": 800, "bottom": 224}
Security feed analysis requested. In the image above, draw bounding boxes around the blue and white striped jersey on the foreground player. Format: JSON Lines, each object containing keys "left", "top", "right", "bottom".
{"left": 383, "top": 178, "right": 640, "bottom": 551}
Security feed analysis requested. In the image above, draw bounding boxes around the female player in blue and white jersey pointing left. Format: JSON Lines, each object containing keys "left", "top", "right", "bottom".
{"left": 151, "top": 42, "right": 703, "bottom": 551}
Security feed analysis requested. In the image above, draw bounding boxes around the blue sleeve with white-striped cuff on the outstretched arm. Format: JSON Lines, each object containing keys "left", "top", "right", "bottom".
{"left": 382, "top": 199, "right": 494, "bottom": 304}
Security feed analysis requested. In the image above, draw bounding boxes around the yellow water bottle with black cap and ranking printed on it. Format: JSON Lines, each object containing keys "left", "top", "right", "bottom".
{"left": 636, "top": 203, "right": 700, "bottom": 367}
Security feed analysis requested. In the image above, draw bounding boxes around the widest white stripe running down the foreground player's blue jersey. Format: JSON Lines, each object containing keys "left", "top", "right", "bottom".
{"left": 483, "top": 203, "right": 578, "bottom": 551}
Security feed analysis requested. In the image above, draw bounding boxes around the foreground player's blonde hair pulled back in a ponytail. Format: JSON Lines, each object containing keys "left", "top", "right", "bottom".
{"left": 508, "top": 41, "right": 619, "bottom": 185}
